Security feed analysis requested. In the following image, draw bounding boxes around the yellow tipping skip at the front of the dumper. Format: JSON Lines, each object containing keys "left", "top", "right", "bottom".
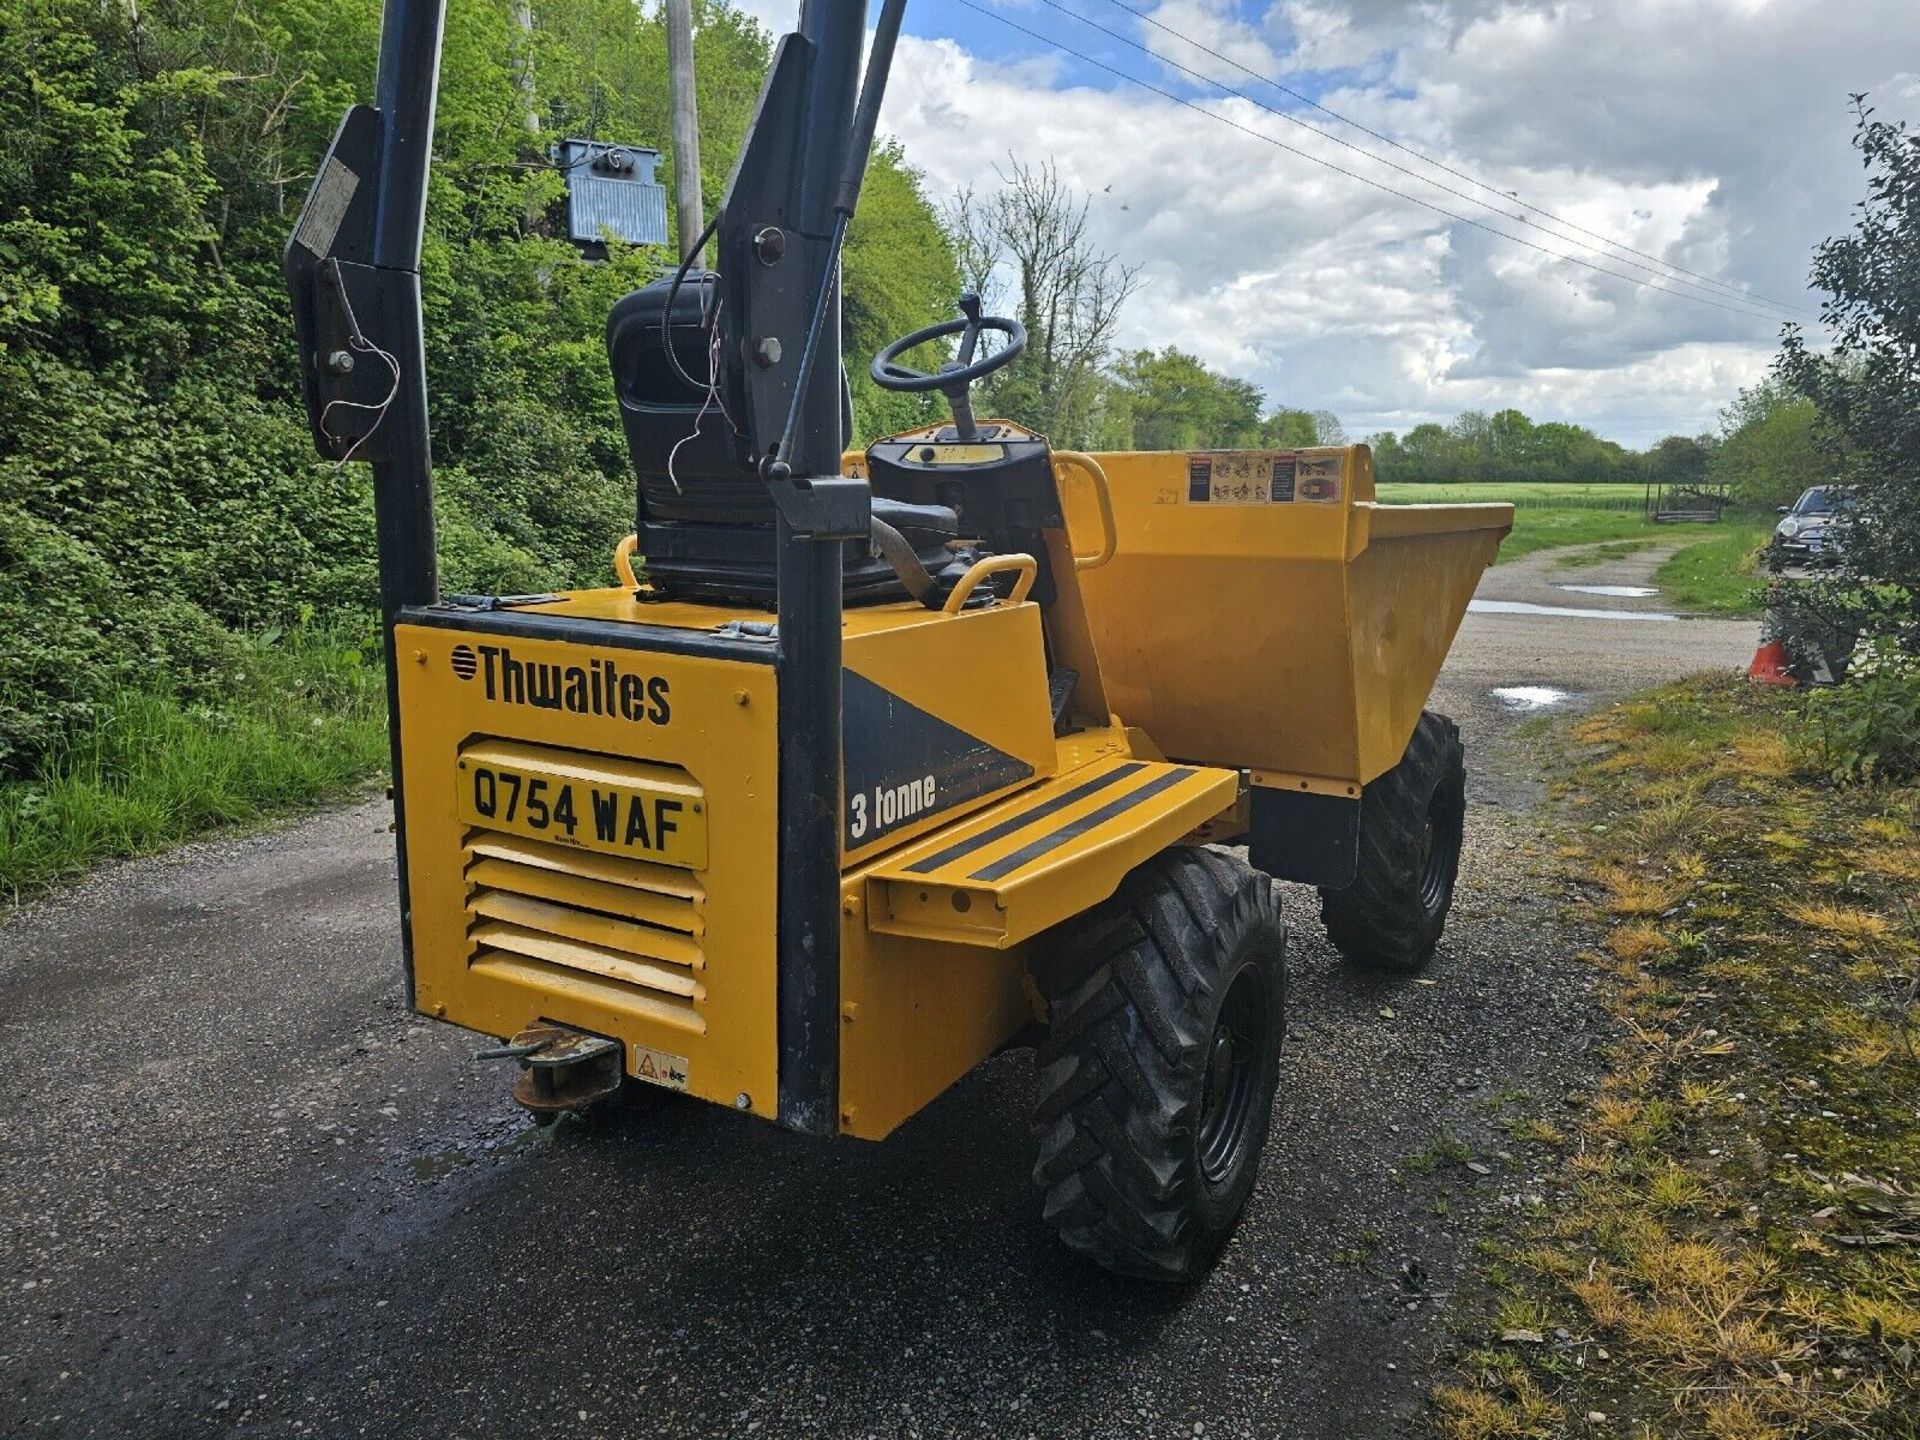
{"left": 1068, "top": 445, "right": 1513, "bottom": 795}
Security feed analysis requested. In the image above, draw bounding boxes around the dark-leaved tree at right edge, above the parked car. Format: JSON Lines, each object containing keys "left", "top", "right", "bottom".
{"left": 1778, "top": 96, "right": 1920, "bottom": 602}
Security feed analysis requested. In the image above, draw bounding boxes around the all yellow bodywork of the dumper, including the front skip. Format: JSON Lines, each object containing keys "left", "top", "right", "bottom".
{"left": 396, "top": 447, "right": 1511, "bottom": 1139}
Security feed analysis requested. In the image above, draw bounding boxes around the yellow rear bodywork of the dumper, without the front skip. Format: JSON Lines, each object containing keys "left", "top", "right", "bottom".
{"left": 397, "top": 589, "right": 1238, "bottom": 1139}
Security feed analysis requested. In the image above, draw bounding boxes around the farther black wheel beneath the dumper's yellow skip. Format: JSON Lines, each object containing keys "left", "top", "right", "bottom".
{"left": 1321, "top": 710, "right": 1467, "bottom": 972}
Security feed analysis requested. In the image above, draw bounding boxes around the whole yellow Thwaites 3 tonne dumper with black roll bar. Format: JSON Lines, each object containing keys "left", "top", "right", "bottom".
{"left": 286, "top": 0, "right": 1511, "bottom": 1281}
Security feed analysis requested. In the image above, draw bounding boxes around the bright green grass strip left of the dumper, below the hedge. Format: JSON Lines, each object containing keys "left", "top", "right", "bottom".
{"left": 0, "top": 639, "right": 386, "bottom": 902}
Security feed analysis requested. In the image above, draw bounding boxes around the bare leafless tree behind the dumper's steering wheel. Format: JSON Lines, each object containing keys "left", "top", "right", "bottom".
{"left": 945, "top": 157, "right": 1140, "bottom": 445}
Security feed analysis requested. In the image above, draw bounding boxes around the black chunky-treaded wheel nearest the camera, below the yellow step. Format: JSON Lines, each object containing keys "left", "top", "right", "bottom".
{"left": 1033, "top": 847, "right": 1286, "bottom": 1281}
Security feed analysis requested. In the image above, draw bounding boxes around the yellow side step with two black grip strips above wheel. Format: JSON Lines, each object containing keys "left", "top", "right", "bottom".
{"left": 868, "top": 758, "right": 1238, "bottom": 950}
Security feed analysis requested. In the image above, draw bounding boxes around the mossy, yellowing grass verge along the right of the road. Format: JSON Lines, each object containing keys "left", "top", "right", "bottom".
{"left": 1434, "top": 680, "right": 1920, "bottom": 1440}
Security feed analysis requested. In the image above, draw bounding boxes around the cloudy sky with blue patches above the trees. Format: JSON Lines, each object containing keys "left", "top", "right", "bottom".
{"left": 721, "top": 0, "right": 1920, "bottom": 445}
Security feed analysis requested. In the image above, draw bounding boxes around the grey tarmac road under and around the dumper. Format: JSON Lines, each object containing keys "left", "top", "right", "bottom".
{"left": 0, "top": 557, "right": 1755, "bottom": 1438}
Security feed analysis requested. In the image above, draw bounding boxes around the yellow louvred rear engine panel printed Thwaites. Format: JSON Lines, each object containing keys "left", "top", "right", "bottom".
{"left": 396, "top": 626, "right": 780, "bottom": 1116}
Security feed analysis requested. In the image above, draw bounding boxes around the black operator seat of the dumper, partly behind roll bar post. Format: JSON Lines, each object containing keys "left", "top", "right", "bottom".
{"left": 607, "top": 271, "right": 958, "bottom": 605}
